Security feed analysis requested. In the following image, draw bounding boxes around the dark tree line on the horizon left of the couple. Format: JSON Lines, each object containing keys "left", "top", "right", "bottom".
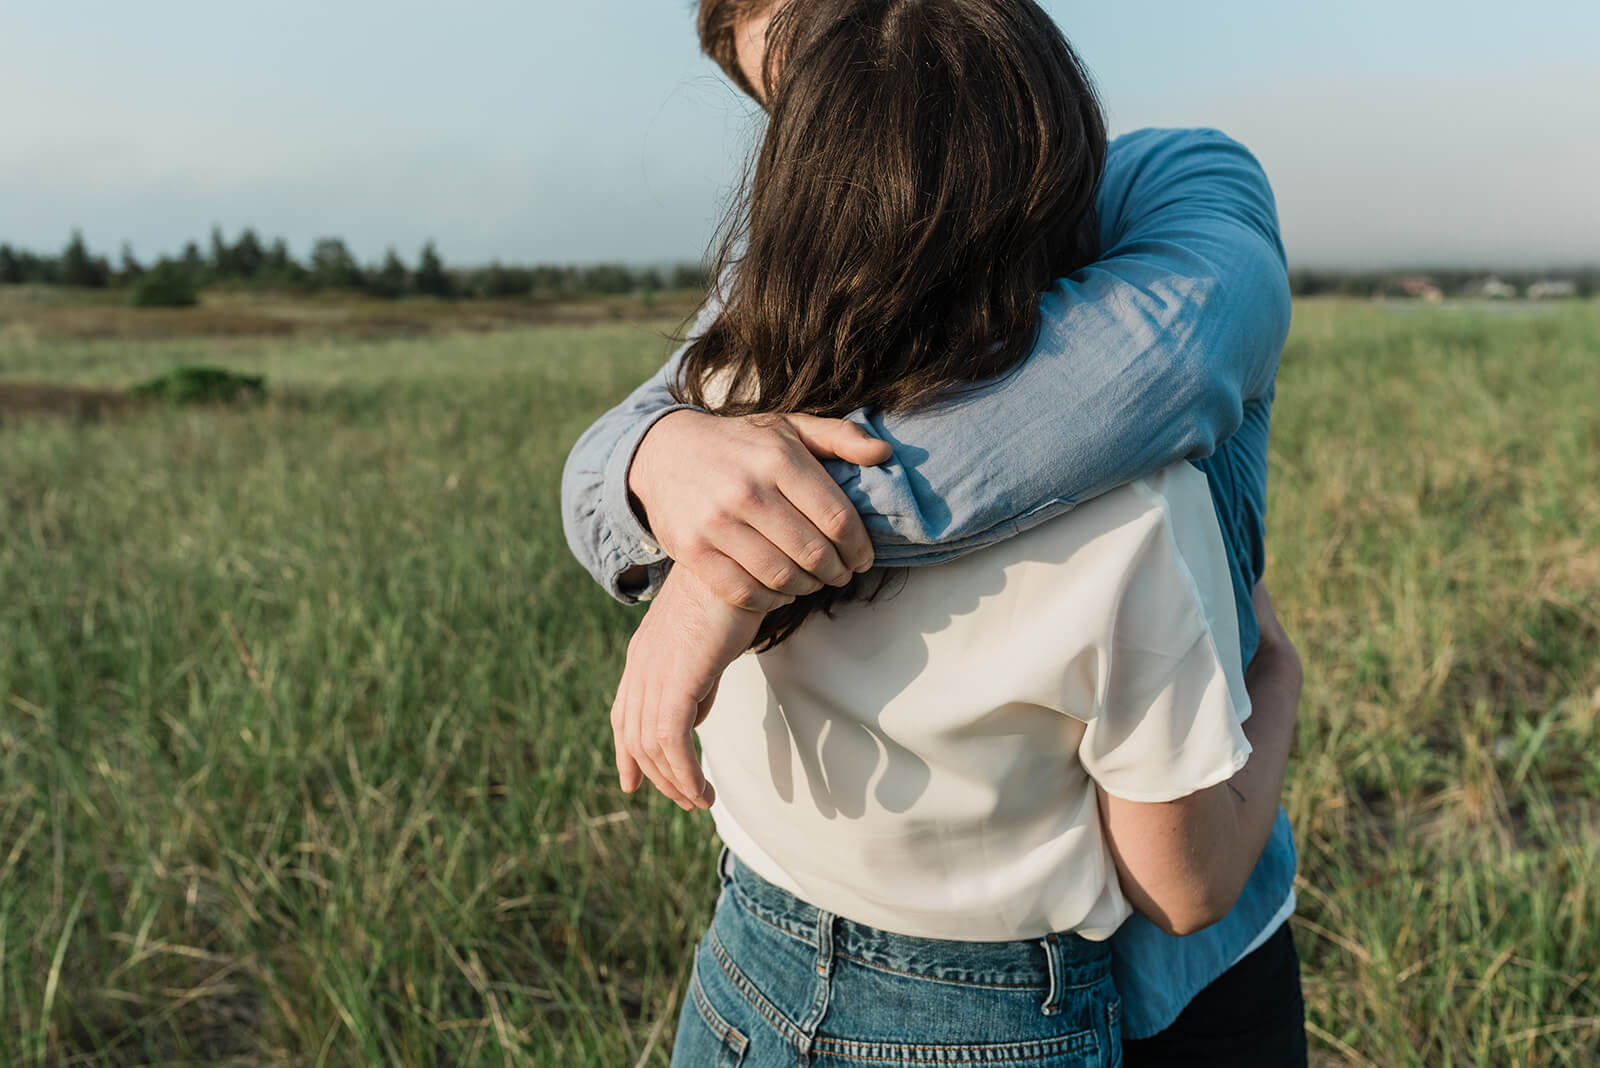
{"left": 0, "top": 227, "right": 707, "bottom": 305}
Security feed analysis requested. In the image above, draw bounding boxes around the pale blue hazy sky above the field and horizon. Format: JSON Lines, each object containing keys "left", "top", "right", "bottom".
{"left": 0, "top": 0, "right": 1600, "bottom": 265}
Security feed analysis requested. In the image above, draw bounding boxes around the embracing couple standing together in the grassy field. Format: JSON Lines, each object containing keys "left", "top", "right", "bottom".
{"left": 563, "top": 0, "right": 1306, "bottom": 1068}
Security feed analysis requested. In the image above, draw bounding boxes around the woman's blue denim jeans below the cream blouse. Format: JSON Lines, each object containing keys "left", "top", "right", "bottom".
{"left": 672, "top": 851, "right": 1122, "bottom": 1068}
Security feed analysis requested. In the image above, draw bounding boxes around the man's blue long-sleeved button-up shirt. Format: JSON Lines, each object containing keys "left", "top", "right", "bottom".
{"left": 562, "top": 130, "right": 1294, "bottom": 1038}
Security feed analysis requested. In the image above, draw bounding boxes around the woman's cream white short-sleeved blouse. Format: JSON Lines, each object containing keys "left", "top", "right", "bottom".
{"left": 699, "top": 464, "right": 1250, "bottom": 942}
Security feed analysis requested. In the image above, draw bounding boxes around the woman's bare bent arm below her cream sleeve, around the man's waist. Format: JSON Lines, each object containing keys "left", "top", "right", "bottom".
{"left": 1099, "top": 584, "right": 1302, "bottom": 935}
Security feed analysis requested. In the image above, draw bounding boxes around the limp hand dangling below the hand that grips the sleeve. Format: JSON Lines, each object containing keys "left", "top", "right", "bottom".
{"left": 611, "top": 568, "right": 763, "bottom": 811}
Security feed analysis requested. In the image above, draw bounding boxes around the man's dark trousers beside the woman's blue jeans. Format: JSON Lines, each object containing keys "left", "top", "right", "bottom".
{"left": 1123, "top": 924, "right": 1306, "bottom": 1068}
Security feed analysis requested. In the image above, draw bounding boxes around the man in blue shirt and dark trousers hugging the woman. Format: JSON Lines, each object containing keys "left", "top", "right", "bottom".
{"left": 563, "top": 0, "right": 1304, "bottom": 1065}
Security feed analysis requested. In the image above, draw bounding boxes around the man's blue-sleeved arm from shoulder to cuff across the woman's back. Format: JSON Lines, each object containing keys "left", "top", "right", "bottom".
{"left": 851, "top": 130, "right": 1290, "bottom": 564}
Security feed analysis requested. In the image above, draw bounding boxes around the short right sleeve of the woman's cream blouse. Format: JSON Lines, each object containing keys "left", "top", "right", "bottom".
{"left": 1078, "top": 464, "right": 1250, "bottom": 803}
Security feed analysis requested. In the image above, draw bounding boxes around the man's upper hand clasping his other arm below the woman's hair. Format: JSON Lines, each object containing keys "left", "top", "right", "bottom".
{"left": 627, "top": 409, "right": 893, "bottom": 613}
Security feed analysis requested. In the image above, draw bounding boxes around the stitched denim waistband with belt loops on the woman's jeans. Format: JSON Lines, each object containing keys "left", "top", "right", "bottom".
{"left": 718, "top": 849, "right": 1110, "bottom": 990}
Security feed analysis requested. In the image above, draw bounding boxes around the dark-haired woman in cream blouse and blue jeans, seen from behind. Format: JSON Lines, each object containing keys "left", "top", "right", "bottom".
{"left": 604, "top": 0, "right": 1286, "bottom": 1065}
